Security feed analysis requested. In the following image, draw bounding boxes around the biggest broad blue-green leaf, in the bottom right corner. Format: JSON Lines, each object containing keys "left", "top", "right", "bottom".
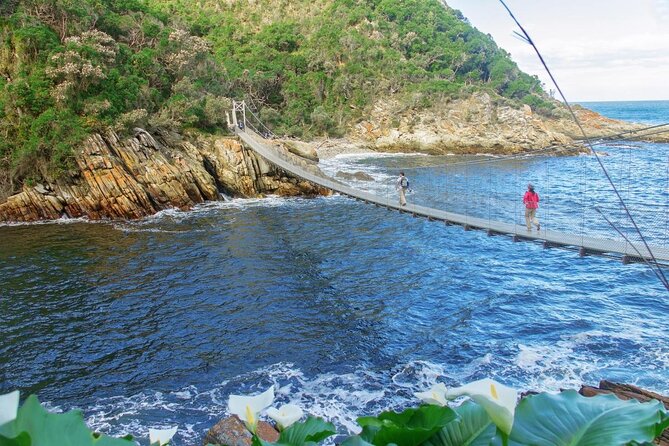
{"left": 510, "top": 390, "right": 665, "bottom": 446}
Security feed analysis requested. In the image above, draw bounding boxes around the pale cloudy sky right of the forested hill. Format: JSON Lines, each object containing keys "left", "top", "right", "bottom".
{"left": 445, "top": 0, "right": 669, "bottom": 102}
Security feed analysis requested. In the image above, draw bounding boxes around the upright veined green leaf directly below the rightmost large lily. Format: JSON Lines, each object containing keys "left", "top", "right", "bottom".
{"left": 424, "top": 401, "right": 497, "bottom": 446}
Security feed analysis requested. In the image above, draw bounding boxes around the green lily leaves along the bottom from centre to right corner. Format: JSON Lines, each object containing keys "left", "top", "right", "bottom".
{"left": 254, "top": 391, "right": 669, "bottom": 446}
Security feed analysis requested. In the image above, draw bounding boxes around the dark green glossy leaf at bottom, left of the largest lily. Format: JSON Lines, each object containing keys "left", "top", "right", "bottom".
{"left": 358, "top": 405, "right": 458, "bottom": 446}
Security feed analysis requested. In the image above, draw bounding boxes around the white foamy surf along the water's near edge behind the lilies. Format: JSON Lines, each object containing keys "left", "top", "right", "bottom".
{"left": 75, "top": 344, "right": 669, "bottom": 445}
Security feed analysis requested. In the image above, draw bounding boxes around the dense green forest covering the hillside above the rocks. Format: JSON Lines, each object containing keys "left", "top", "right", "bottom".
{"left": 0, "top": 0, "right": 553, "bottom": 200}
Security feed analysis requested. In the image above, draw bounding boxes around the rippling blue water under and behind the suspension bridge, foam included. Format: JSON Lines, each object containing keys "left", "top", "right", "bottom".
{"left": 0, "top": 103, "right": 669, "bottom": 445}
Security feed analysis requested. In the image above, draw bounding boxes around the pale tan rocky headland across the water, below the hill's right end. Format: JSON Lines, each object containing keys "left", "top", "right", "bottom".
{"left": 352, "top": 93, "right": 667, "bottom": 154}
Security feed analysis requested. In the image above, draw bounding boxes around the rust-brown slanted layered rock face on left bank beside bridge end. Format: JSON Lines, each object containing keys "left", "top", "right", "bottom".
{"left": 0, "top": 129, "right": 329, "bottom": 222}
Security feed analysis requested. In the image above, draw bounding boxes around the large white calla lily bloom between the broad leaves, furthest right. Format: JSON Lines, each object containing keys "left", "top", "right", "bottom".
{"left": 446, "top": 378, "right": 518, "bottom": 435}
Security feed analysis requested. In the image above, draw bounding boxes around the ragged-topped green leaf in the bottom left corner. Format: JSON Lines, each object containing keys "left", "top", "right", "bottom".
{"left": 0, "top": 395, "right": 135, "bottom": 446}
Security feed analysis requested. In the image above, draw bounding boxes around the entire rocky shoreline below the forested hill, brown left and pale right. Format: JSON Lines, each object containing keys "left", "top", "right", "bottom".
{"left": 0, "top": 93, "right": 669, "bottom": 222}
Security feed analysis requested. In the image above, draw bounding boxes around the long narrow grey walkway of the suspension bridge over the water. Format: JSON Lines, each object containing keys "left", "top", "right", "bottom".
{"left": 236, "top": 129, "right": 669, "bottom": 265}
